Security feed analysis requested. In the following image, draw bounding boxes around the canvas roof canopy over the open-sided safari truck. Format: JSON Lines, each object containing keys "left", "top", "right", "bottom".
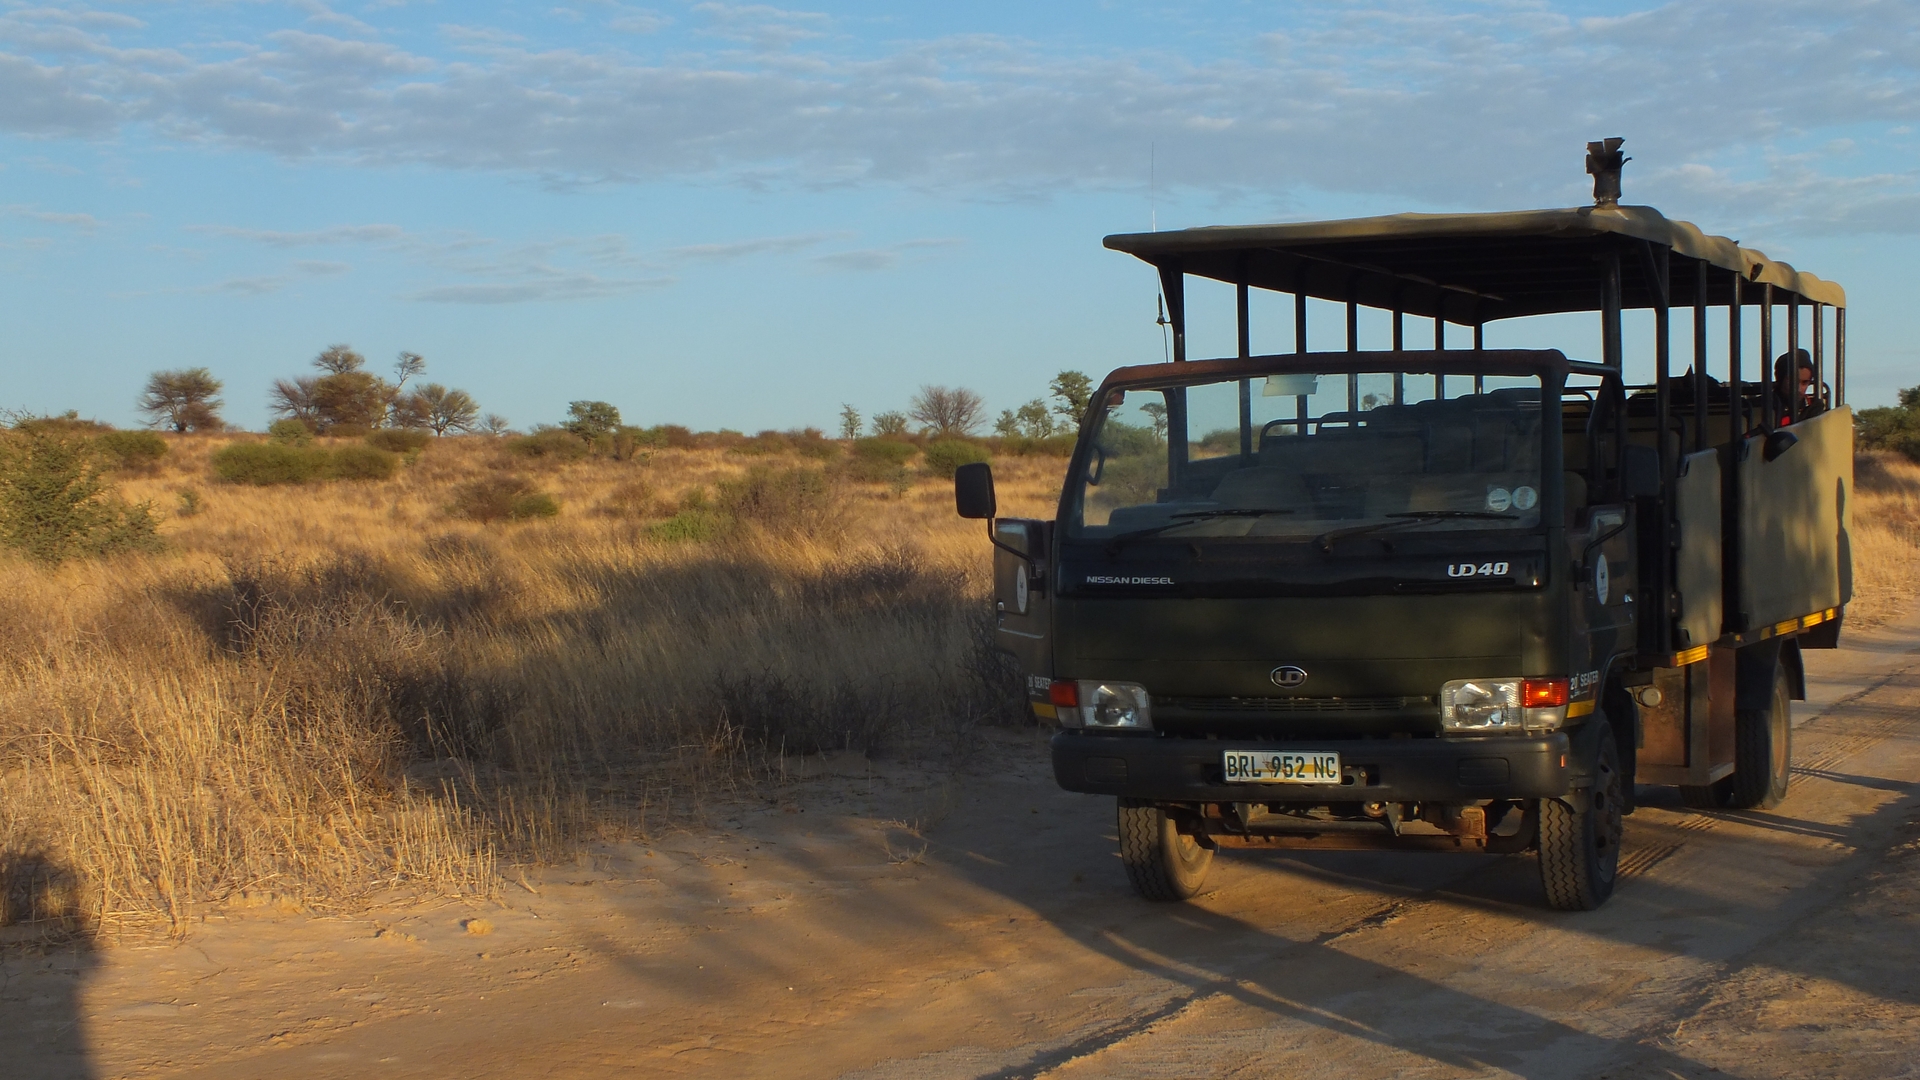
{"left": 1106, "top": 206, "right": 1847, "bottom": 323}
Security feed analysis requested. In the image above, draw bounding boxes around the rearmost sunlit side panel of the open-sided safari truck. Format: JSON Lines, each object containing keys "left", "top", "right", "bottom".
{"left": 1740, "top": 407, "right": 1853, "bottom": 628}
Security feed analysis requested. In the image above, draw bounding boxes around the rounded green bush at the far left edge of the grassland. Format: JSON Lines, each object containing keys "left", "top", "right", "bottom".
{"left": 0, "top": 427, "right": 159, "bottom": 563}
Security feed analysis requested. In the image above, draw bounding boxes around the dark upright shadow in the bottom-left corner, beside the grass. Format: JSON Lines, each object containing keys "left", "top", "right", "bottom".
{"left": 0, "top": 849, "right": 98, "bottom": 1080}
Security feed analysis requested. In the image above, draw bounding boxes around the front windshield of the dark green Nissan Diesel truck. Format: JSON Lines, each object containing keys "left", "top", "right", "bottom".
{"left": 1068, "top": 371, "right": 1542, "bottom": 546}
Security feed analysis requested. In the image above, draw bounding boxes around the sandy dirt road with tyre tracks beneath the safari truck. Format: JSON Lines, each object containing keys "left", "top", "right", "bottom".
{"left": 0, "top": 611, "right": 1920, "bottom": 1080}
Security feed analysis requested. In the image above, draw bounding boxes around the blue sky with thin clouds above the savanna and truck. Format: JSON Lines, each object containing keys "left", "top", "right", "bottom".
{"left": 0, "top": 0, "right": 1920, "bottom": 430}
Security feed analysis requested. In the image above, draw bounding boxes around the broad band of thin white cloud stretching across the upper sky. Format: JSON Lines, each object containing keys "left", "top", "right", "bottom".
{"left": 0, "top": 0, "right": 1920, "bottom": 231}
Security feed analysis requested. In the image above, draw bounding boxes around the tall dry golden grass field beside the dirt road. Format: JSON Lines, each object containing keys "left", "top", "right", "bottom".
{"left": 0, "top": 436, "right": 1920, "bottom": 932}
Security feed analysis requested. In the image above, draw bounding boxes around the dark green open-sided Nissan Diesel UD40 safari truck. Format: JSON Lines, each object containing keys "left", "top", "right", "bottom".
{"left": 954, "top": 140, "right": 1853, "bottom": 909}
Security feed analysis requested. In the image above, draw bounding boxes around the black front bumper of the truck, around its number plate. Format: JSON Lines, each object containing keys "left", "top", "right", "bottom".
{"left": 1052, "top": 730, "right": 1572, "bottom": 805}
